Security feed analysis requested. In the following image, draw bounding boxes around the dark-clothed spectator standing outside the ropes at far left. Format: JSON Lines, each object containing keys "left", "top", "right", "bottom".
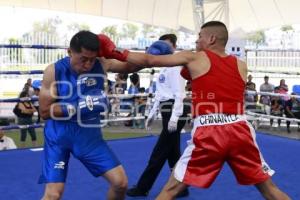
{"left": 17, "top": 91, "right": 36, "bottom": 148}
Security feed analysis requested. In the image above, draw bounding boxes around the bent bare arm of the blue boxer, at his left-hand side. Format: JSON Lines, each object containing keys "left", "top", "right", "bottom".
{"left": 39, "top": 65, "right": 63, "bottom": 119}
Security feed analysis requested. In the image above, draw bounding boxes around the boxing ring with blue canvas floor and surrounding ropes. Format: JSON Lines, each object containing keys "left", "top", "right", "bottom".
{"left": 0, "top": 44, "right": 300, "bottom": 200}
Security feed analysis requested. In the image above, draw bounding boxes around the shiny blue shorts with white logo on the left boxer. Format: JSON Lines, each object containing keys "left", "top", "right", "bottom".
{"left": 39, "top": 120, "right": 120, "bottom": 183}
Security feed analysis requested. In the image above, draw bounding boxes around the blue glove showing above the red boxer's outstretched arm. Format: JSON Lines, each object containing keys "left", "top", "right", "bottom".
{"left": 146, "top": 40, "right": 174, "bottom": 55}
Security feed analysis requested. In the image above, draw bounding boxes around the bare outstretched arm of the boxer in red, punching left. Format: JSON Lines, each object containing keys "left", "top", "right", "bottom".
{"left": 127, "top": 51, "right": 195, "bottom": 67}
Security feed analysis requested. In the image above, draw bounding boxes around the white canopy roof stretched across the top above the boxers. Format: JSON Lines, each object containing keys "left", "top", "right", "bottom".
{"left": 0, "top": 0, "right": 300, "bottom": 32}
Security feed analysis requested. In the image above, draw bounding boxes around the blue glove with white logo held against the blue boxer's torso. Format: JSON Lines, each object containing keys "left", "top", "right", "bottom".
{"left": 61, "top": 89, "right": 109, "bottom": 119}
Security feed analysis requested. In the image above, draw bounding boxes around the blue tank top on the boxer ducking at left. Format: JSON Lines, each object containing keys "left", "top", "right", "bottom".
{"left": 55, "top": 57, "right": 105, "bottom": 123}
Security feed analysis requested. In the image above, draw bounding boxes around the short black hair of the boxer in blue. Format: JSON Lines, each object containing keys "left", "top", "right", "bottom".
{"left": 70, "top": 31, "right": 100, "bottom": 53}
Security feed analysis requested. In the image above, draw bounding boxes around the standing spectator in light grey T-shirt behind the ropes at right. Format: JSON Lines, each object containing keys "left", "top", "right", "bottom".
{"left": 259, "top": 76, "right": 274, "bottom": 115}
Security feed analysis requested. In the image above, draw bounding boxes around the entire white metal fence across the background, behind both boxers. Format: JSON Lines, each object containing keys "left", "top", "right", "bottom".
{"left": 0, "top": 33, "right": 300, "bottom": 71}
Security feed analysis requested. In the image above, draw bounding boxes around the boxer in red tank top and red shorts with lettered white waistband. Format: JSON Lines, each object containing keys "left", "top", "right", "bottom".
{"left": 102, "top": 21, "right": 290, "bottom": 200}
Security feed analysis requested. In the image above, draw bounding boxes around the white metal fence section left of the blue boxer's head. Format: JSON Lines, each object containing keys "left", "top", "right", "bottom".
{"left": 0, "top": 33, "right": 67, "bottom": 71}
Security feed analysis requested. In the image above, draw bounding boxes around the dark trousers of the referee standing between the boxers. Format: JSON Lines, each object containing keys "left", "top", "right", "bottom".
{"left": 137, "top": 100, "right": 187, "bottom": 192}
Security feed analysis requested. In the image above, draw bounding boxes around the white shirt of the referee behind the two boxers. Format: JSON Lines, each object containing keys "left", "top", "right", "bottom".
{"left": 155, "top": 66, "right": 185, "bottom": 120}
